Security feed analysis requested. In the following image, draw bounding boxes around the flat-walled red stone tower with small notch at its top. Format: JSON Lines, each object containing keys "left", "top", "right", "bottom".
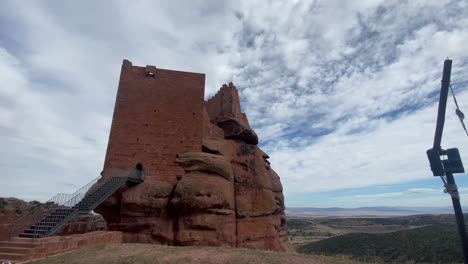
{"left": 104, "top": 60, "right": 205, "bottom": 184}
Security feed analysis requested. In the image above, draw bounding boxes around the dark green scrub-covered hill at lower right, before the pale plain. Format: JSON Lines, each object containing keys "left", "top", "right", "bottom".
{"left": 297, "top": 224, "right": 463, "bottom": 263}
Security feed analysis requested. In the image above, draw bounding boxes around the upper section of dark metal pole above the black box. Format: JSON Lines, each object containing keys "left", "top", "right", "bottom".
{"left": 433, "top": 59, "right": 452, "bottom": 150}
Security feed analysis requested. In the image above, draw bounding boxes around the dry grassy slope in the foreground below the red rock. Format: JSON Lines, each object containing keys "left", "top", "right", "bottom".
{"left": 29, "top": 244, "right": 370, "bottom": 264}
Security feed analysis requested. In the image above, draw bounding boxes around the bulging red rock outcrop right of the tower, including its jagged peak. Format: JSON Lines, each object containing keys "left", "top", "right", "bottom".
{"left": 169, "top": 83, "right": 290, "bottom": 251}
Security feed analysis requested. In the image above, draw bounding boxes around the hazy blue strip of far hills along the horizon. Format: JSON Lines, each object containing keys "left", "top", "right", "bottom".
{"left": 286, "top": 206, "right": 460, "bottom": 217}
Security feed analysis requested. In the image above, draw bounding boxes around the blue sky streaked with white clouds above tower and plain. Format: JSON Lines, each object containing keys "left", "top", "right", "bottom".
{"left": 0, "top": 0, "right": 468, "bottom": 207}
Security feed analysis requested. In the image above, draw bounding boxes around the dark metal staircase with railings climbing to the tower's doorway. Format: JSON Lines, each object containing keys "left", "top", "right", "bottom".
{"left": 10, "top": 177, "right": 143, "bottom": 238}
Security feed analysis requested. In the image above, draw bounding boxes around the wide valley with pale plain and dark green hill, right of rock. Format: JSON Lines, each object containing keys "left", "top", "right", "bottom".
{"left": 286, "top": 213, "right": 468, "bottom": 263}
